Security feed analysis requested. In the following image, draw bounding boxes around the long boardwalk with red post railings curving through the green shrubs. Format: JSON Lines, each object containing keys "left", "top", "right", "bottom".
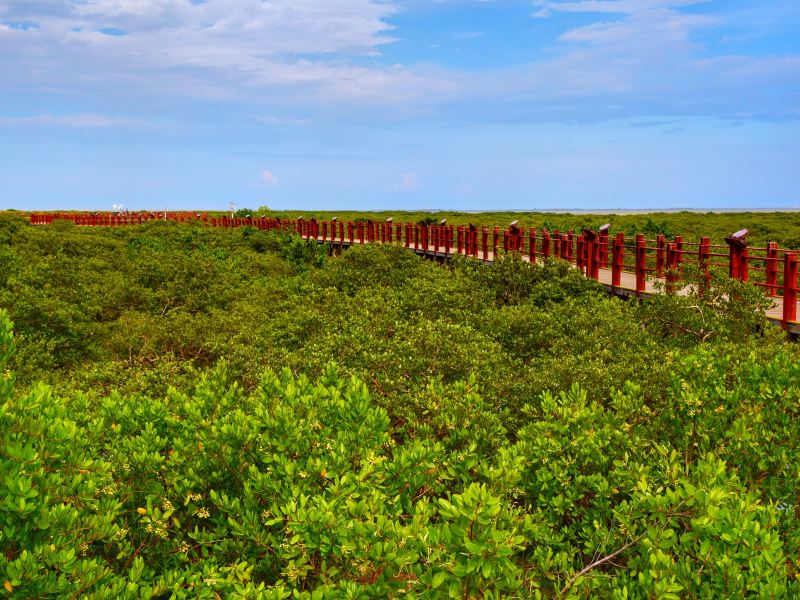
{"left": 30, "top": 212, "right": 798, "bottom": 330}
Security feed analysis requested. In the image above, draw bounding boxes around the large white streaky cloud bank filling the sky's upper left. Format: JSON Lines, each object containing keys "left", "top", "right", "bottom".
{"left": 0, "top": 0, "right": 456, "bottom": 105}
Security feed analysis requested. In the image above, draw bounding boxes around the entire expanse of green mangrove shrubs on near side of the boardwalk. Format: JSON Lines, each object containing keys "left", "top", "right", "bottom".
{"left": 0, "top": 217, "right": 800, "bottom": 599}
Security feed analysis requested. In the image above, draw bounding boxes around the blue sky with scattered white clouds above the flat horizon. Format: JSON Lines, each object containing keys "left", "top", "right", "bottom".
{"left": 0, "top": 0, "right": 800, "bottom": 210}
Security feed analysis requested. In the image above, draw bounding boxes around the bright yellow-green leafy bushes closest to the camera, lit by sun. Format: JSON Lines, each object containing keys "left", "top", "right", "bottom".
{"left": 0, "top": 313, "right": 800, "bottom": 599}
